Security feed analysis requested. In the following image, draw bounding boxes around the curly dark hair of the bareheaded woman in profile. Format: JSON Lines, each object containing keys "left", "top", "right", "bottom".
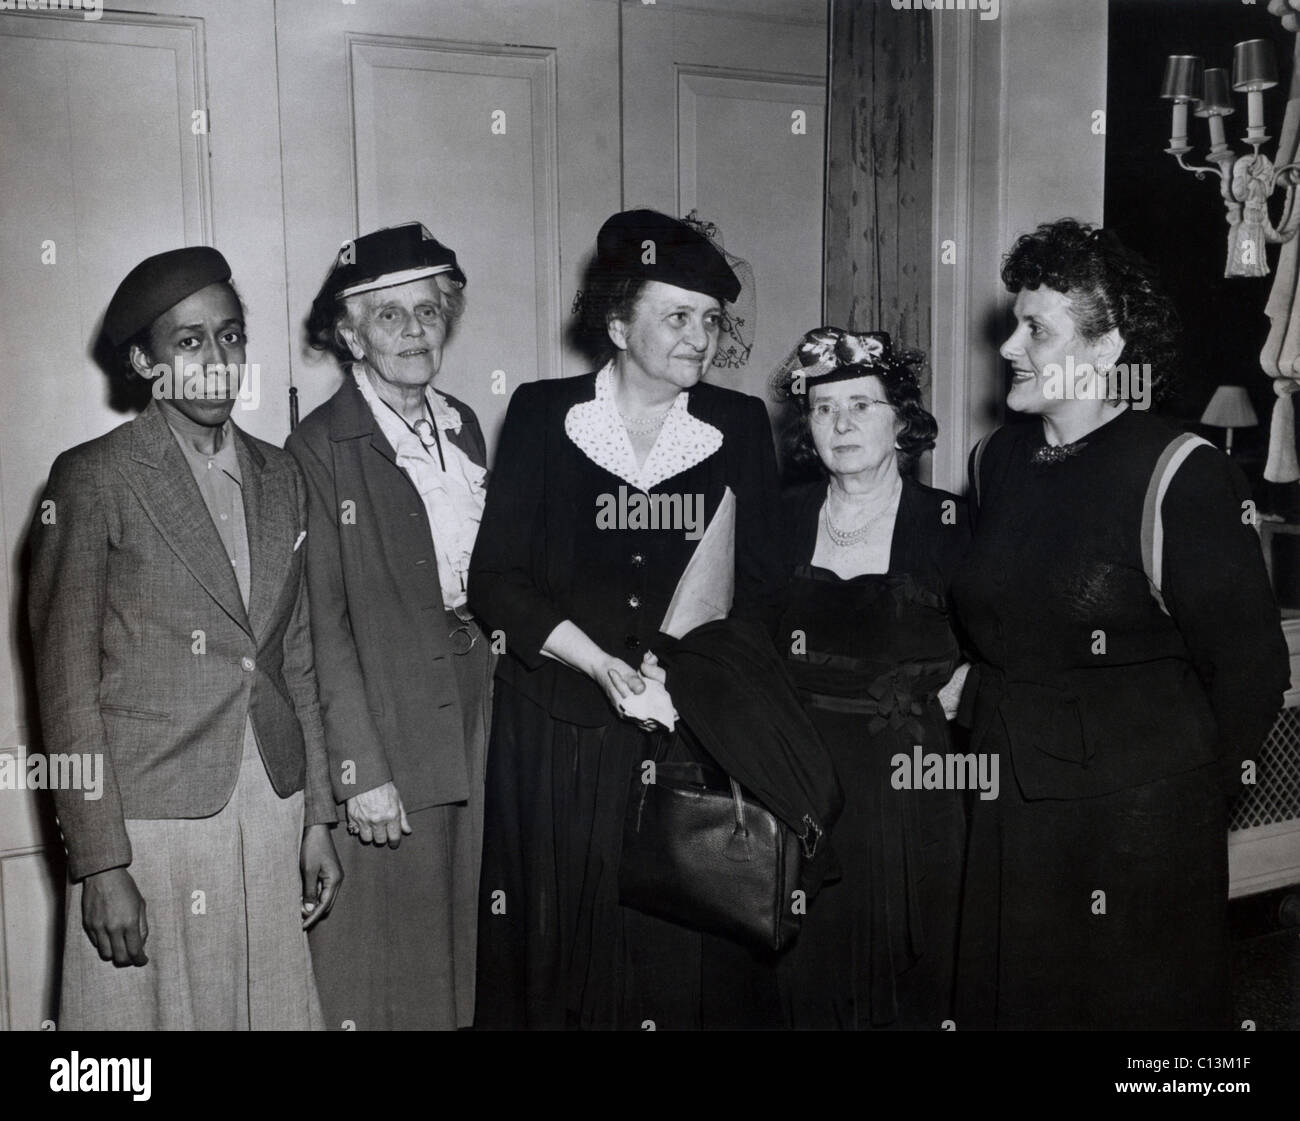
{"left": 1002, "top": 218, "right": 1180, "bottom": 402}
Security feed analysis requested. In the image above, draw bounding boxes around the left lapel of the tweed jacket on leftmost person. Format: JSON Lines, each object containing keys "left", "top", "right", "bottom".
{"left": 121, "top": 402, "right": 256, "bottom": 635}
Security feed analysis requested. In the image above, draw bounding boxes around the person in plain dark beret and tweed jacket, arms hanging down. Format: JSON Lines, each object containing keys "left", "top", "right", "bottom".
{"left": 30, "top": 246, "right": 342, "bottom": 1031}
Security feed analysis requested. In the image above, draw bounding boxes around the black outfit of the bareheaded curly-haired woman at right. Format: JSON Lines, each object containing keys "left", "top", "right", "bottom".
{"left": 953, "top": 410, "right": 1288, "bottom": 1029}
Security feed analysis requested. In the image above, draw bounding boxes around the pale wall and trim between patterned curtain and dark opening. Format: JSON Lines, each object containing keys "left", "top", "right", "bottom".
{"left": 931, "top": 0, "right": 1108, "bottom": 492}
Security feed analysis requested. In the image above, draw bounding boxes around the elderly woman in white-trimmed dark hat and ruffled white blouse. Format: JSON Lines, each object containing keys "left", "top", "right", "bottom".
{"left": 287, "top": 224, "right": 495, "bottom": 1029}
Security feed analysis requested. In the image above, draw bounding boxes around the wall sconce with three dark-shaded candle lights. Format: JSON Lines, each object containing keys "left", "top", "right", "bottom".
{"left": 1160, "top": 39, "right": 1300, "bottom": 277}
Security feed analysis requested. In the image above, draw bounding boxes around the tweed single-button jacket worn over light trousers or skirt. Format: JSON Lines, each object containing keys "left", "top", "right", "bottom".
{"left": 30, "top": 402, "right": 333, "bottom": 879}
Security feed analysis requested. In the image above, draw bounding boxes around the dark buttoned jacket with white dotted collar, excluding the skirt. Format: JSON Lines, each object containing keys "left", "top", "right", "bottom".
{"left": 469, "top": 373, "right": 787, "bottom": 727}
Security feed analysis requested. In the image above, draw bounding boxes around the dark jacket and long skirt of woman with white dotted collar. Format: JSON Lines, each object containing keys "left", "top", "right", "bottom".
{"left": 469, "top": 375, "right": 785, "bottom": 1029}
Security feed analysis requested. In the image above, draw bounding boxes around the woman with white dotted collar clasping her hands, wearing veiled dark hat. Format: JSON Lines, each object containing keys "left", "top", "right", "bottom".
{"left": 469, "top": 211, "right": 784, "bottom": 1027}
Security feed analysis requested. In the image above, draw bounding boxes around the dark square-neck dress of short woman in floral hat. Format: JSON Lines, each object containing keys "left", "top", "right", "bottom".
{"left": 779, "top": 480, "right": 970, "bottom": 1029}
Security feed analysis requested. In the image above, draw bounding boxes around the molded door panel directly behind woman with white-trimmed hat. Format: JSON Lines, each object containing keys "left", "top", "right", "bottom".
{"left": 350, "top": 39, "right": 562, "bottom": 436}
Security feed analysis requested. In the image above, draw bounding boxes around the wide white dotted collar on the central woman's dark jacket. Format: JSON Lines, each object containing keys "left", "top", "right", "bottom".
{"left": 564, "top": 362, "right": 723, "bottom": 493}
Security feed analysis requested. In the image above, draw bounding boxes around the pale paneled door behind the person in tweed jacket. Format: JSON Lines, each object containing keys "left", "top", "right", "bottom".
{"left": 0, "top": 0, "right": 289, "bottom": 1030}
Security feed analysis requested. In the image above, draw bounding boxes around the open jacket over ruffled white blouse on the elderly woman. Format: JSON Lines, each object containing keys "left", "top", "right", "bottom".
{"left": 285, "top": 376, "right": 486, "bottom": 811}
